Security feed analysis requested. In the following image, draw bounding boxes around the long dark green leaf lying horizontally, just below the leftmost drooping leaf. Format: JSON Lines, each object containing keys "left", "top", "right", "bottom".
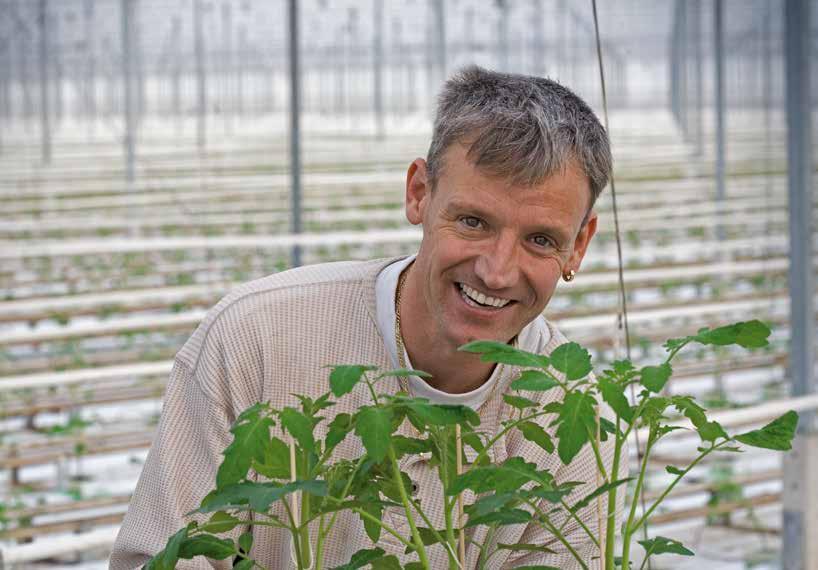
{"left": 197, "top": 479, "right": 327, "bottom": 513}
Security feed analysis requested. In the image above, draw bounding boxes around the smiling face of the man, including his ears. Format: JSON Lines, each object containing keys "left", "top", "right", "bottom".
{"left": 406, "top": 144, "right": 596, "bottom": 348}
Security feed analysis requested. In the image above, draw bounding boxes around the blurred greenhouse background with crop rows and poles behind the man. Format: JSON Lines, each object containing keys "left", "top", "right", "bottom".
{"left": 0, "top": 0, "right": 818, "bottom": 569}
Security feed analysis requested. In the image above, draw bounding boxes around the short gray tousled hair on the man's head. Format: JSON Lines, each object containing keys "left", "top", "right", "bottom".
{"left": 426, "top": 65, "right": 613, "bottom": 210}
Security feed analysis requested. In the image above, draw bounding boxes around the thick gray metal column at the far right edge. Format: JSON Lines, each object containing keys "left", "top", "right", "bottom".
{"left": 782, "top": 0, "right": 818, "bottom": 560}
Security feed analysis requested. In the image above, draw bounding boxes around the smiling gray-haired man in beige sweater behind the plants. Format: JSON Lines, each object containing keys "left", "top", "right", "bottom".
{"left": 111, "top": 67, "right": 611, "bottom": 570}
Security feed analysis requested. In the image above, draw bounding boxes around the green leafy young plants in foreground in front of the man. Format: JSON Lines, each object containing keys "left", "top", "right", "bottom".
{"left": 145, "top": 321, "right": 798, "bottom": 570}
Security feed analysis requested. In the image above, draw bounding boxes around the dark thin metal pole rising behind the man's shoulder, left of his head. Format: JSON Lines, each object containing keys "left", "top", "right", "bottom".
{"left": 287, "top": 0, "right": 301, "bottom": 267}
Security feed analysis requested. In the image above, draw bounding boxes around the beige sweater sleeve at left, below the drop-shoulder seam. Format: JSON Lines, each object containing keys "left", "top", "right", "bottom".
{"left": 109, "top": 358, "right": 246, "bottom": 570}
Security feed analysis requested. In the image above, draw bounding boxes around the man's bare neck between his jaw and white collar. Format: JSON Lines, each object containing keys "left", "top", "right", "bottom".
{"left": 396, "top": 266, "right": 495, "bottom": 394}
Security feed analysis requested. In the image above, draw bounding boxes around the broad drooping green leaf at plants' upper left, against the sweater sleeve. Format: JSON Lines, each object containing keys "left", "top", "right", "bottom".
{"left": 216, "top": 404, "right": 275, "bottom": 487}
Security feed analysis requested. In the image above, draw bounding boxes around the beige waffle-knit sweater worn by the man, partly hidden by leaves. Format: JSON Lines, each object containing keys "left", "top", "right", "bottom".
{"left": 110, "top": 260, "right": 627, "bottom": 570}
